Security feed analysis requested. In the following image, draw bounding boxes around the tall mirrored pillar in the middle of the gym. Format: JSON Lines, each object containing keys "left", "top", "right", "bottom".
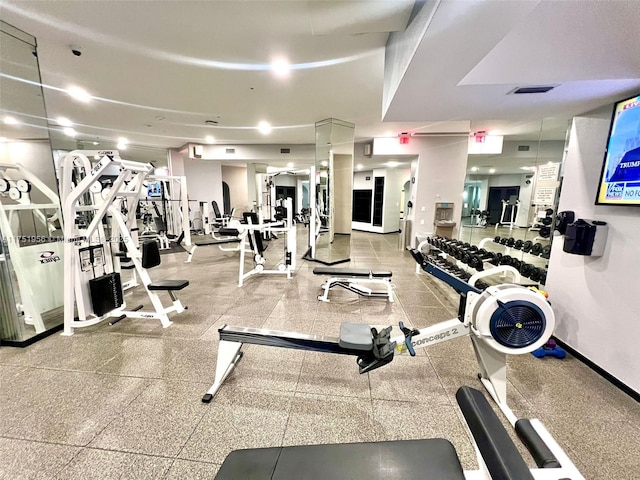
{"left": 305, "top": 118, "right": 355, "bottom": 265}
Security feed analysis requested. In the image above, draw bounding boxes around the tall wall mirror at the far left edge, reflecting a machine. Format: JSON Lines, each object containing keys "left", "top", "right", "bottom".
{"left": 0, "top": 22, "right": 64, "bottom": 346}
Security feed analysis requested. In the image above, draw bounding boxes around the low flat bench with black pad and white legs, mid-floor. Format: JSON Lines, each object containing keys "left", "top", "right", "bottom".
{"left": 313, "top": 267, "right": 393, "bottom": 302}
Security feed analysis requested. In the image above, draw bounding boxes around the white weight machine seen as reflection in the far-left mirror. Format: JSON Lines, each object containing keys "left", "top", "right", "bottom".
{"left": 0, "top": 163, "right": 64, "bottom": 333}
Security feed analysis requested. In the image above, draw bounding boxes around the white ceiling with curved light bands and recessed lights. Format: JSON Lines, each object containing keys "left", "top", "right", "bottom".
{"left": 0, "top": 0, "right": 640, "bottom": 171}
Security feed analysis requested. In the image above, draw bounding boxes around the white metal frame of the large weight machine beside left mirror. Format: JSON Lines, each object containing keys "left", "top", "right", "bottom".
{"left": 60, "top": 150, "right": 185, "bottom": 335}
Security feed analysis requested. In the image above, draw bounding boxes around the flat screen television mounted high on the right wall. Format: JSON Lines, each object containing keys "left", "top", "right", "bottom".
{"left": 596, "top": 95, "right": 640, "bottom": 206}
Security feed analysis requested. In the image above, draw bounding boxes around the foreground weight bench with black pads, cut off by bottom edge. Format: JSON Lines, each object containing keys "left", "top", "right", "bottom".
{"left": 215, "top": 386, "right": 584, "bottom": 480}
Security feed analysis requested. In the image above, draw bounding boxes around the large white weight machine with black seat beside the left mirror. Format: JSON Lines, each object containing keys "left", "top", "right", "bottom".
{"left": 60, "top": 150, "right": 189, "bottom": 335}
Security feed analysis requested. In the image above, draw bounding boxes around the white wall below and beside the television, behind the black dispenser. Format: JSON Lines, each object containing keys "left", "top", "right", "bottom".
{"left": 546, "top": 107, "right": 640, "bottom": 392}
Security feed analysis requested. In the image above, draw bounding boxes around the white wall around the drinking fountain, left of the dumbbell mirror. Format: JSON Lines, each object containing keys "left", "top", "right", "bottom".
{"left": 373, "top": 135, "right": 468, "bottom": 241}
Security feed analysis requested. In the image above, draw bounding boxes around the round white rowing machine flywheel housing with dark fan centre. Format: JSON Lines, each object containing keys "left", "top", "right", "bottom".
{"left": 472, "top": 285, "right": 555, "bottom": 354}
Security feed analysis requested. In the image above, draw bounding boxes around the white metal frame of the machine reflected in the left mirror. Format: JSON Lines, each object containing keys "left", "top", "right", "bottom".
{"left": 0, "top": 163, "right": 64, "bottom": 333}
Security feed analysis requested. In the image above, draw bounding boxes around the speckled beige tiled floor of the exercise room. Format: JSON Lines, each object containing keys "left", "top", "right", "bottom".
{"left": 0, "top": 227, "right": 640, "bottom": 480}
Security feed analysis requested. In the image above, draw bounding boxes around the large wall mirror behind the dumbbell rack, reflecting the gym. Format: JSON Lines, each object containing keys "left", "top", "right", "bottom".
{"left": 456, "top": 118, "right": 568, "bottom": 285}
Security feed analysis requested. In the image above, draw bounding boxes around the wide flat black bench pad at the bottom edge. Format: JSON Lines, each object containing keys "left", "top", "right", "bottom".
{"left": 216, "top": 438, "right": 464, "bottom": 480}
